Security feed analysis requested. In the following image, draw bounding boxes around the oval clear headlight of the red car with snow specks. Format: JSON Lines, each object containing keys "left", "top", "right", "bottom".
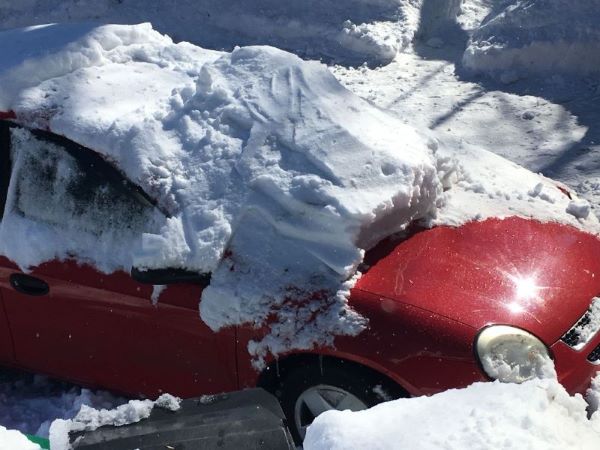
{"left": 475, "top": 325, "right": 555, "bottom": 383}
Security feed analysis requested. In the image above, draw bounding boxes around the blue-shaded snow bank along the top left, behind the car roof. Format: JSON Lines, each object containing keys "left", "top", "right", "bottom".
{"left": 0, "top": 0, "right": 460, "bottom": 65}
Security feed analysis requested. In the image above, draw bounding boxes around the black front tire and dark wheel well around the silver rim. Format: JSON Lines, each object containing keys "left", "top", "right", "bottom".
{"left": 275, "top": 359, "right": 407, "bottom": 444}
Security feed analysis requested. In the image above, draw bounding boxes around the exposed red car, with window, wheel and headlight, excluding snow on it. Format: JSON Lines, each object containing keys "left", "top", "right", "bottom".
{"left": 0, "top": 117, "right": 600, "bottom": 439}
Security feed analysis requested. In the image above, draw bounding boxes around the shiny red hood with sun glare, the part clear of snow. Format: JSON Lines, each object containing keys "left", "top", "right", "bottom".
{"left": 356, "top": 217, "right": 600, "bottom": 345}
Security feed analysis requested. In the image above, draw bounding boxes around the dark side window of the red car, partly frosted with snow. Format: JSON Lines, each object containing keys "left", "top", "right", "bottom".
{"left": 10, "top": 128, "right": 155, "bottom": 237}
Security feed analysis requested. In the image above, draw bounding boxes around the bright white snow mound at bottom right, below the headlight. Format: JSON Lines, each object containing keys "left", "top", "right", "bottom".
{"left": 304, "top": 379, "right": 600, "bottom": 450}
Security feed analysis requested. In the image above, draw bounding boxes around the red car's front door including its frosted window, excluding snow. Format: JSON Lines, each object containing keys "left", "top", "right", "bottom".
{"left": 0, "top": 122, "right": 237, "bottom": 396}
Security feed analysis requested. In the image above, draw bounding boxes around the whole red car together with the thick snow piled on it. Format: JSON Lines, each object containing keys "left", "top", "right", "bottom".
{"left": 0, "top": 24, "right": 600, "bottom": 439}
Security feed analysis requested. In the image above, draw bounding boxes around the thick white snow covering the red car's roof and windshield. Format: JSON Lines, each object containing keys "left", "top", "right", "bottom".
{"left": 0, "top": 24, "right": 597, "bottom": 362}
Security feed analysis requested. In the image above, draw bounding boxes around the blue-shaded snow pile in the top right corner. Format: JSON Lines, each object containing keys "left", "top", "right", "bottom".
{"left": 463, "top": 0, "right": 600, "bottom": 82}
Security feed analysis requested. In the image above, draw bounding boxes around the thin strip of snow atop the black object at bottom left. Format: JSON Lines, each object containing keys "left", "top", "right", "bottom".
{"left": 50, "top": 394, "right": 181, "bottom": 450}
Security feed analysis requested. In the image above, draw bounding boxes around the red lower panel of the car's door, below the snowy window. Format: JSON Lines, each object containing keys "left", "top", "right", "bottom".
{"left": 0, "top": 258, "right": 237, "bottom": 397}
